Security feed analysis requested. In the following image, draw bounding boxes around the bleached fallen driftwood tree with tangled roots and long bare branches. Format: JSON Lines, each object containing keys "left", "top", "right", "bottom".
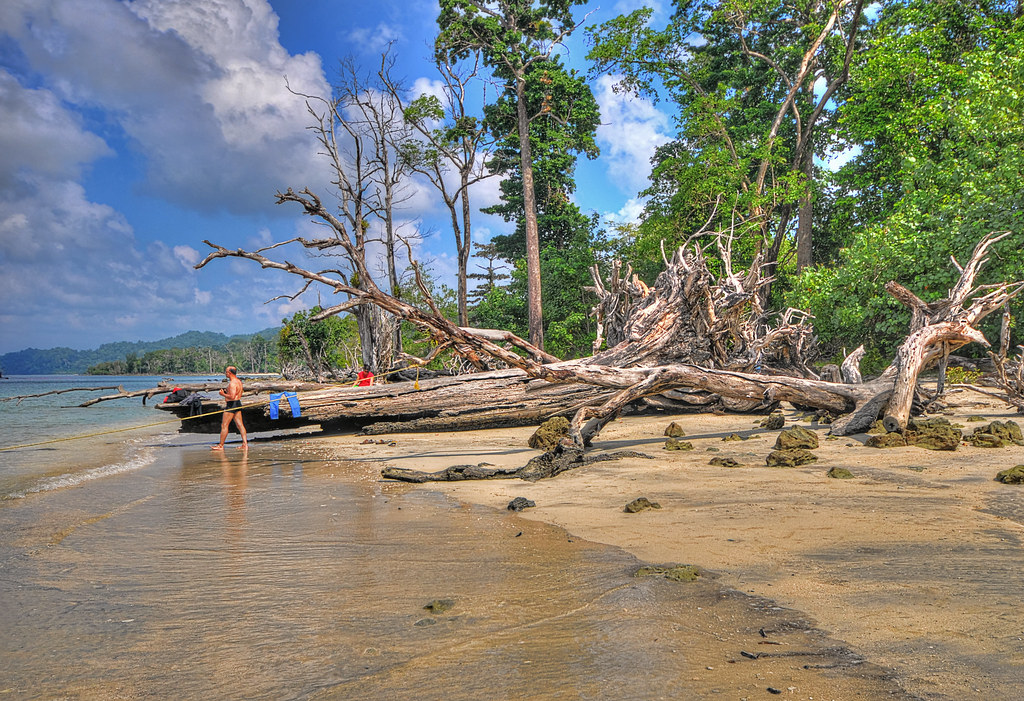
{"left": 197, "top": 229, "right": 1024, "bottom": 447}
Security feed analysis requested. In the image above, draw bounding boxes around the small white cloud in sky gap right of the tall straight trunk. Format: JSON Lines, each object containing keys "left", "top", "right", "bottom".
{"left": 595, "top": 76, "right": 671, "bottom": 192}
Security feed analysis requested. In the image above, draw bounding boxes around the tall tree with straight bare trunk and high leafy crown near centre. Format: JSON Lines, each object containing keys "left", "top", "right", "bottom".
{"left": 435, "top": 0, "right": 584, "bottom": 348}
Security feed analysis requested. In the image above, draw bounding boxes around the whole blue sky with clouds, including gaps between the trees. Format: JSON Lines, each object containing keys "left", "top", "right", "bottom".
{"left": 0, "top": 0, "right": 672, "bottom": 353}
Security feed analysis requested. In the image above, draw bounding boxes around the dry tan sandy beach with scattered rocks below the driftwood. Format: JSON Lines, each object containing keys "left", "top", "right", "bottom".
{"left": 327, "top": 391, "right": 1024, "bottom": 699}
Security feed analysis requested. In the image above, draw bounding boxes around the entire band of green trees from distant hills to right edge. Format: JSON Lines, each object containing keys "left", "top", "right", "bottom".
{"left": 49, "top": 0, "right": 1024, "bottom": 376}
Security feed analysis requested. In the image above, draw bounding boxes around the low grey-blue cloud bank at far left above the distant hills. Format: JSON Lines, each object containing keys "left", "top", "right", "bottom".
{"left": 0, "top": 171, "right": 218, "bottom": 350}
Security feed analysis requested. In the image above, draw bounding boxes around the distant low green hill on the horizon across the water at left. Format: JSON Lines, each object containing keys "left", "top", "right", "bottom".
{"left": 0, "top": 327, "right": 281, "bottom": 375}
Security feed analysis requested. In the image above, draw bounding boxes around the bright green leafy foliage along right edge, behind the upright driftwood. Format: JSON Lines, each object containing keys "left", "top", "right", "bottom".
{"left": 788, "top": 1, "right": 1024, "bottom": 351}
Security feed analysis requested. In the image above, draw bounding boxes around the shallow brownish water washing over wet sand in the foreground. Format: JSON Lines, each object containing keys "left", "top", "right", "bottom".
{"left": 0, "top": 440, "right": 905, "bottom": 699}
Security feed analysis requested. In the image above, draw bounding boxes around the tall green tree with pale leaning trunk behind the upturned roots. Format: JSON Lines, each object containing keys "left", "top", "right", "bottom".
{"left": 589, "top": 0, "right": 863, "bottom": 278}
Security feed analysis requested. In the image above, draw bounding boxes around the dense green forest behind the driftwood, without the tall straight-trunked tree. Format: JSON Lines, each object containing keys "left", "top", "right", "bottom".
{"left": 471, "top": 0, "right": 1024, "bottom": 369}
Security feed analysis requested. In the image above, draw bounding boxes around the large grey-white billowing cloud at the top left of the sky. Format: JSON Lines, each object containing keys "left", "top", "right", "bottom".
{"left": 0, "top": 0, "right": 329, "bottom": 213}
